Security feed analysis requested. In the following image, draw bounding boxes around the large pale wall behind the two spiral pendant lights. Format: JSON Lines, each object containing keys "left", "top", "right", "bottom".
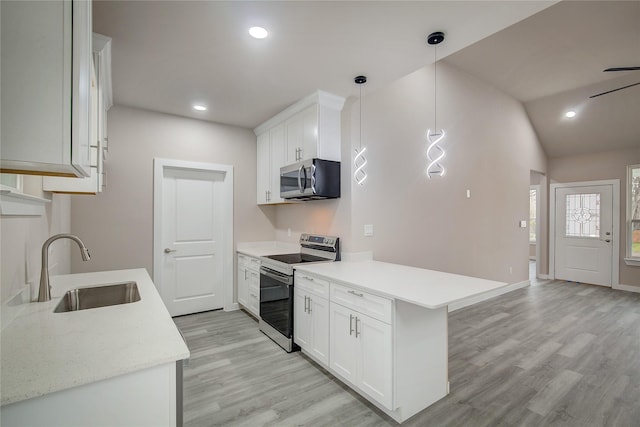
{"left": 276, "top": 63, "right": 547, "bottom": 283}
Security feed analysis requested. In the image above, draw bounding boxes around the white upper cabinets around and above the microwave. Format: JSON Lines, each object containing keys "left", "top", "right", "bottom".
{"left": 254, "top": 91, "right": 345, "bottom": 205}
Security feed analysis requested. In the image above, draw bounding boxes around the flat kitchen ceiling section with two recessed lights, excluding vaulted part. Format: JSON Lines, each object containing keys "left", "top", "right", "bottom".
{"left": 93, "top": 1, "right": 554, "bottom": 128}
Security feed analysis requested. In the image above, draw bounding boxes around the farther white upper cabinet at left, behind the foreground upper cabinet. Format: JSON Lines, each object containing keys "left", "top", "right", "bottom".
{"left": 42, "top": 33, "right": 113, "bottom": 194}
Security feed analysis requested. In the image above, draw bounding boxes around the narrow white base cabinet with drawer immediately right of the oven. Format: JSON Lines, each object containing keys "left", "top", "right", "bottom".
{"left": 293, "top": 275, "right": 329, "bottom": 367}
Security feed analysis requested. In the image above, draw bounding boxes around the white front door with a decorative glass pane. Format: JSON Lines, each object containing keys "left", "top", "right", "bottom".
{"left": 554, "top": 184, "right": 617, "bottom": 287}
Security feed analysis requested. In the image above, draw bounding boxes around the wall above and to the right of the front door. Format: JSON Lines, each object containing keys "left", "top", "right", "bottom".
{"left": 549, "top": 147, "right": 640, "bottom": 286}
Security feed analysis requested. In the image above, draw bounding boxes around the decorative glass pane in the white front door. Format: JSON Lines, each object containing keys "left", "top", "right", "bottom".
{"left": 566, "top": 194, "right": 600, "bottom": 238}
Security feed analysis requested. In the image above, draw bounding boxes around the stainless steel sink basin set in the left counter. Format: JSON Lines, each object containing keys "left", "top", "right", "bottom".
{"left": 53, "top": 282, "right": 140, "bottom": 313}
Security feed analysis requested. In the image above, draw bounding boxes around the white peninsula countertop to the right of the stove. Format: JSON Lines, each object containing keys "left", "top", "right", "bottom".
{"left": 295, "top": 261, "right": 508, "bottom": 309}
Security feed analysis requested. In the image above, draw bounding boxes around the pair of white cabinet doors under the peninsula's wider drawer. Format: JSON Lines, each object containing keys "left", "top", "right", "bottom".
{"left": 330, "top": 302, "right": 393, "bottom": 409}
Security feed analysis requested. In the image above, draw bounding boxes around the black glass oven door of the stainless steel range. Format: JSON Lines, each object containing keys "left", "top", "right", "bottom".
{"left": 260, "top": 266, "right": 293, "bottom": 338}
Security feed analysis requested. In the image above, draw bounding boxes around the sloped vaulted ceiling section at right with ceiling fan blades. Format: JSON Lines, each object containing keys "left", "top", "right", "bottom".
{"left": 445, "top": 1, "right": 640, "bottom": 157}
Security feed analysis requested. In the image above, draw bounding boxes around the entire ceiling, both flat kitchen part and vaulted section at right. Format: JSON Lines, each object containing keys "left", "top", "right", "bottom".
{"left": 93, "top": 0, "right": 640, "bottom": 157}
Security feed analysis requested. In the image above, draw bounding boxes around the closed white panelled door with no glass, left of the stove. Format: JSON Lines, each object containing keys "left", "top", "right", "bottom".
{"left": 154, "top": 159, "right": 233, "bottom": 316}
